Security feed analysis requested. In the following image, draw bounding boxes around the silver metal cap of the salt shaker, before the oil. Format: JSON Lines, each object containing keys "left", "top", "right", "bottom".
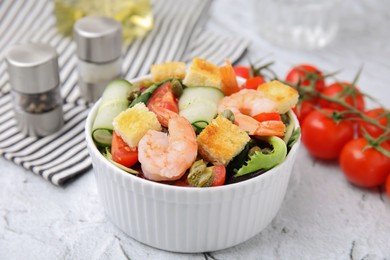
{"left": 73, "top": 16, "right": 122, "bottom": 63}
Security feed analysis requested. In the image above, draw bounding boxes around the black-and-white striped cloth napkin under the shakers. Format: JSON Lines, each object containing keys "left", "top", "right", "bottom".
{"left": 0, "top": 0, "right": 249, "bottom": 185}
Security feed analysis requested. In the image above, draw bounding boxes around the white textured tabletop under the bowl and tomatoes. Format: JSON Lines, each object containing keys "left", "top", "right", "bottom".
{"left": 0, "top": 0, "right": 390, "bottom": 259}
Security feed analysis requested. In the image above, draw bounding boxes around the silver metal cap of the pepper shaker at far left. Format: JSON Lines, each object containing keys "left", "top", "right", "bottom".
{"left": 6, "top": 43, "right": 60, "bottom": 94}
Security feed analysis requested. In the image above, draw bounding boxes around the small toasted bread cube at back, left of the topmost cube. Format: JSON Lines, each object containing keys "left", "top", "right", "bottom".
{"left": 150, "top": 61, "right": 186, "bottom": 82}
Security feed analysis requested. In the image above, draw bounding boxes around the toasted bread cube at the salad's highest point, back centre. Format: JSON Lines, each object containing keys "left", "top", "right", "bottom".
{"left": 183, "top": 58, "right": 222, "bottom": 88}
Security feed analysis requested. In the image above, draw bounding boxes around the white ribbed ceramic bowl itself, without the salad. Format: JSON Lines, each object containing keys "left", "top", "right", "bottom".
{"left": 85, "top": 76, "right": 300, "bottom": 253}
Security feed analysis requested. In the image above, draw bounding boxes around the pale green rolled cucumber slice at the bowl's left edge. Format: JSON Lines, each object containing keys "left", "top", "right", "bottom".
{"left": 92, "top": 80, "right": 135, "bottom": 146}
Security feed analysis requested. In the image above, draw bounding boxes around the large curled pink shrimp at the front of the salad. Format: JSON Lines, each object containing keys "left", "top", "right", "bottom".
{"left": 138, "top": 116, "right": 198, "bottom": 181}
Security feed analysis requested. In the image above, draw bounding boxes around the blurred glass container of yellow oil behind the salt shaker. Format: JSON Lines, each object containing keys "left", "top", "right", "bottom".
{"left": 54, "top": 0, "right": 153, "bottom": 43}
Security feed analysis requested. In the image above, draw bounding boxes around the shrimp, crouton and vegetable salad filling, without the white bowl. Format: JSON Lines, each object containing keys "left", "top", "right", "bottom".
{"left": 92, "top": 58, "right": 299, "bottom": 187}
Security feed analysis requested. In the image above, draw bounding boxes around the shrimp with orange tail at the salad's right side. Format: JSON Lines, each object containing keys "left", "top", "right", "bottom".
{"left": 218, "top": 89, "right": 286, "bottom": 136}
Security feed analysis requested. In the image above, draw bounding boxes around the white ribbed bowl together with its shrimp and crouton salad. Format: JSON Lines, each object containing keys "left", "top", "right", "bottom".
{"left": 85, "top": 58, "right": 300, "bottom": 253}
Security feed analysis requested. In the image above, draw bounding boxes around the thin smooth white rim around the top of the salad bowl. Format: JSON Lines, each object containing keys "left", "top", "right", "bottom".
{"left": 84, "top": 75, "right": 301, "bottom": 194}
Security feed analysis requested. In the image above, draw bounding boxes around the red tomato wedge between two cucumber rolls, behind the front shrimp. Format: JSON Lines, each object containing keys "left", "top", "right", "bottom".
{"left": 147, "top": 81, "right": 179, "bottom": 113}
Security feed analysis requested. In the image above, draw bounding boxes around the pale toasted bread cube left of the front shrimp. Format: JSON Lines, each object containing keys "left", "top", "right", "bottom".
{"left": 113, "top": 103, "right": 161, "bottom": 147}
